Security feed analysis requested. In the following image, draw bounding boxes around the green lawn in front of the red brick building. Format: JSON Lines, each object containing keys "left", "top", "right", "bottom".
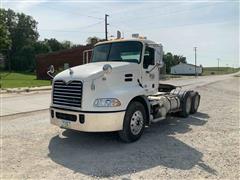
{"left": 0, "top": 71, "right": 50, "bottom": 89}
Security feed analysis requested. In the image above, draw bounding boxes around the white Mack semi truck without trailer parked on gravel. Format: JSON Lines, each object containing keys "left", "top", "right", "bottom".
{"left": 49, "top": 38, "right": 200, "bottom": 142}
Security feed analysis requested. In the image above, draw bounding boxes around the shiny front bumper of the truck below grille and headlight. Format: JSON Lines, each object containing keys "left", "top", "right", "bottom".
{"left": 50, "top": 107, "right": 125, "bottom": 132}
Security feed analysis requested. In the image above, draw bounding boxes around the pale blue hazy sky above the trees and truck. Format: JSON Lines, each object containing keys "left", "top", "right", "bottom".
{"left": 0, "top": 0, "right": 239, "bottom": 67}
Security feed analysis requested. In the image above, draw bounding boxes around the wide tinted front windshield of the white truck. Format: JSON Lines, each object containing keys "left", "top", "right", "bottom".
{"left": 92, "top": 41, "right": 142, "bottom": 63}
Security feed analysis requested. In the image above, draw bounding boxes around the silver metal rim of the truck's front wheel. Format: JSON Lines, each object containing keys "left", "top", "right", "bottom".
{"left": 130, "top": 111, "right": 143, "bottom": 135}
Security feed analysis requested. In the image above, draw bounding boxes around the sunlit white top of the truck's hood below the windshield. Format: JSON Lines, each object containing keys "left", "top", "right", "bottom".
{"left": 54, "top": 61, "right": 138, "bottom": 81}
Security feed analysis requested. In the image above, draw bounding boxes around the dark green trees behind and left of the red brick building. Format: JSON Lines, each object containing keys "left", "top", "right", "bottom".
{"left": 0, "top": 9, "right": 76, "bottom": 71}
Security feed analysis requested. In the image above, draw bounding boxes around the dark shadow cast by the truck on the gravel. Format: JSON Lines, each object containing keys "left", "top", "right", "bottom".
{"left": 48, "top": 113, "right": 215, "bottom": 177}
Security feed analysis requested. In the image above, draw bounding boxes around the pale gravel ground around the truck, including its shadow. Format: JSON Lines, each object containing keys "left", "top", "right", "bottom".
{"left": 0, "top": 76, "right": 240, "bottom": 180}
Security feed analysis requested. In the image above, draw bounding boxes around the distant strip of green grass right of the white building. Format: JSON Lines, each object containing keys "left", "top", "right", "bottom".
{"left": 203, "top": 67, "right": 240, "bottom": 76}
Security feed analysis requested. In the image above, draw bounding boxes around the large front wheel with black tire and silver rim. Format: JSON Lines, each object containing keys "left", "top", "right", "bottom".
{"left": 118, "top": 102, "right": 146, "bottom": 142}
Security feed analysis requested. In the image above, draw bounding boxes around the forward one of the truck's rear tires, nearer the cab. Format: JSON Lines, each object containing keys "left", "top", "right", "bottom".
{"left": 179, "top": 91, "right": 192, "bottom": 118}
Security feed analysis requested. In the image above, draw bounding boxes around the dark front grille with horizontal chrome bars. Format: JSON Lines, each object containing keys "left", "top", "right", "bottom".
{"left": 53, "top": 80, "right": 82, "bottom": 107}
